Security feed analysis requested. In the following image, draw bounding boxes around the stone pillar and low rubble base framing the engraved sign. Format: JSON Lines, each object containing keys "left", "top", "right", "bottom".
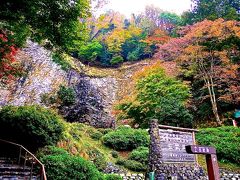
{"left": 149, "top": 120, "right": 207, "bottom": 180}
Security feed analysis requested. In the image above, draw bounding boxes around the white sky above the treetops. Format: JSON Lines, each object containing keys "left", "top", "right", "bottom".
{"left": 100, "top": 0, "right": 191, "bottom": 17}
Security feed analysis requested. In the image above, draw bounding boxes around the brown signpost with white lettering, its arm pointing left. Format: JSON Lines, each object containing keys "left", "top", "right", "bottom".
{"left": 186, "top": 145, "right": 220, "bottom": 180}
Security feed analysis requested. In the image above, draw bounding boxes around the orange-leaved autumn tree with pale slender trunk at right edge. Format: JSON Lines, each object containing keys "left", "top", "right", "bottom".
{"left": 156, "top": 19, "right": 240, "bottom": 125}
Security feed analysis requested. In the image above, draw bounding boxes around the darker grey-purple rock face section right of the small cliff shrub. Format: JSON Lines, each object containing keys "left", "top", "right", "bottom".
{"left": 60, "top": 73, "right": 117, "bottom": 128}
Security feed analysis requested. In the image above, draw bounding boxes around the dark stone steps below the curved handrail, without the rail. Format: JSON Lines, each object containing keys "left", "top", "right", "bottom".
{"left": 0, "top": 157, "right": 38, "bottom": 180}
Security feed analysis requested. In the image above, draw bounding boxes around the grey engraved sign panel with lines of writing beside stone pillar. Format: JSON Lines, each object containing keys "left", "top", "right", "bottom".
{"left": 159, "top": 129, "right": 195, "bottom": 163}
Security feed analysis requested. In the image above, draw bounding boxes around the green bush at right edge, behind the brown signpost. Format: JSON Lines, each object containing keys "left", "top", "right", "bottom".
{"left": 196, "top": 127, "right": 240, "bottom": 164}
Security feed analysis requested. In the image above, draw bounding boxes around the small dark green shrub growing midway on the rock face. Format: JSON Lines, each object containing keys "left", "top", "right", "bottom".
{"left": 57, "top": 85, "right": 76, "bottom": 106}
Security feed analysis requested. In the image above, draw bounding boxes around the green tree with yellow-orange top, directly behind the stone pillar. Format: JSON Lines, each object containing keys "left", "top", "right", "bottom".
{"left": 117, "top": 64, "right": 192, "bottom": 127}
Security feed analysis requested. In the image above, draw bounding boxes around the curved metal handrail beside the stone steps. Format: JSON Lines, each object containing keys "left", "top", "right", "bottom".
{"left": 0, "top": 139, "right": 47, "bottom": 180}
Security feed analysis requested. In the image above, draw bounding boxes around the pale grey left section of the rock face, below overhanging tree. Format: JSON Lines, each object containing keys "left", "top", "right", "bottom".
{"left": 8, "top": 41, "right": 66, "bottom": 106}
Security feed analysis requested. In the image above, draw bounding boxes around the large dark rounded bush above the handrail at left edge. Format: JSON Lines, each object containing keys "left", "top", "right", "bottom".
{"left": 0, "top": 106, "right": 64, "bottom": 150}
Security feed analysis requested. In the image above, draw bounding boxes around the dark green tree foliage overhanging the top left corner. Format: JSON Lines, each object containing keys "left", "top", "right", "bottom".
{"left": 0, "top": 0, "right": 90, "bottom": 51}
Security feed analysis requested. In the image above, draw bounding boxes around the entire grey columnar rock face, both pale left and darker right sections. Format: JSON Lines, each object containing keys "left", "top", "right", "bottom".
{"left": 0, "top": 41, "right": 118, "bottom": 127}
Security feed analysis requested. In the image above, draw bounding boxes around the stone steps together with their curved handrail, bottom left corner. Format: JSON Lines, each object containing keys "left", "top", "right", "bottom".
{"left": 0, "top": 139, "right": 47, "bottom": 180}
